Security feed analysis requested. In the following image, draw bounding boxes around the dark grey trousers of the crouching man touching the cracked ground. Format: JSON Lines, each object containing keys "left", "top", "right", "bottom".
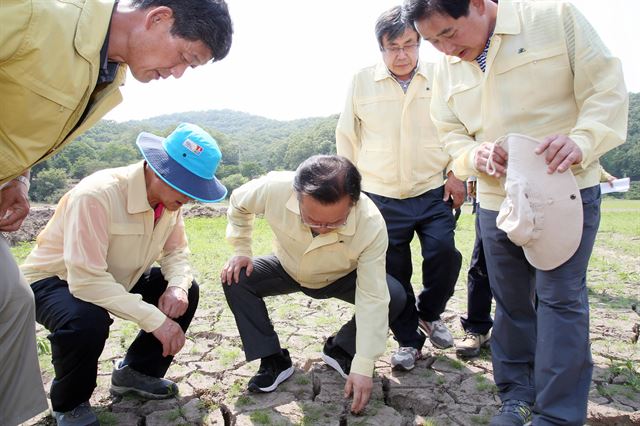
{"left": 222, "top": 256, "right": 407, "bottom": 361}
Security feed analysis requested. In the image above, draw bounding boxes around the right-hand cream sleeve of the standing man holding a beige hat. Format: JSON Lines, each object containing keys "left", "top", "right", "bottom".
{"left": 563, "top": 3, "right": 629, "bottom": 168}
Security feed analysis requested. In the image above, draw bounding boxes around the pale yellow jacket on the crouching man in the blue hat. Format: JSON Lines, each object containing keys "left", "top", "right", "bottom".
{"left": 21, "top": 162, "right": 193, "bottom": 332}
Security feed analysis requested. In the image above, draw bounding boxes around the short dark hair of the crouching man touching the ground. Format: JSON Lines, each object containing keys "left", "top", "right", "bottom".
{"left": 293, "top": 155, "right": 362, "bottom": 204}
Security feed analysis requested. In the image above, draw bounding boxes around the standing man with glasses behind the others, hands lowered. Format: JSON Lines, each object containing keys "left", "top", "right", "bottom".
{"left": 336, "top": 6, "right": 464, "bottom": 370}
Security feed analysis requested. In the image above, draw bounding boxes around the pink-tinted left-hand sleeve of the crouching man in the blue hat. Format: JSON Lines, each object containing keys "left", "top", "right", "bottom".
{"left": 63, "top": 193, "right": 166, "bottom": 332}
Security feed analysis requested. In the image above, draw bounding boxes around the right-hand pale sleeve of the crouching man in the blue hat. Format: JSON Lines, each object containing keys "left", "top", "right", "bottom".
{"left": 158, "top": 210, "right": 193, "bottom": 293}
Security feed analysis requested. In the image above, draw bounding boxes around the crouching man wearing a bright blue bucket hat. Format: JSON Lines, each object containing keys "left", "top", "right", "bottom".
{"left": 22, "top": 124, "right": 227, "bottom": 425}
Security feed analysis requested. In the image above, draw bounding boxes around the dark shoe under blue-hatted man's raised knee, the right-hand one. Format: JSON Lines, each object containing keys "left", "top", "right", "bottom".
{"left": 111, "top": 364, "right": 178, "bottom": 399}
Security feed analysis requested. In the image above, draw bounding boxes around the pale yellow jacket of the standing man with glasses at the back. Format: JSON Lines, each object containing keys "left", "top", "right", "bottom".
{"left": 336, "top": 62, "right": 450, "bottom": 199}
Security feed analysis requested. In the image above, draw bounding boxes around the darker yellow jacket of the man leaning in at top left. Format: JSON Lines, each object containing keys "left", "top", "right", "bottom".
{"left": 0, "top": 0, "right": 127, "bottom": 184}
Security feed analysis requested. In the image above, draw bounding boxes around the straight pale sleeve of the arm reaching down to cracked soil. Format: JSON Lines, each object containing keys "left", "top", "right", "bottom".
{"left": 351, "top": 218, "right": 390, "bottom": 377}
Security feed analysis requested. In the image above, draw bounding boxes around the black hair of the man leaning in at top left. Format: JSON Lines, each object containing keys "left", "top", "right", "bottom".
{"left": 131, "top": 0, "right": 233, "bottom": 62}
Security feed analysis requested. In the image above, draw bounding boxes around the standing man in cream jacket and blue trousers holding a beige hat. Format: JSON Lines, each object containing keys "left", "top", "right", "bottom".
{"left": 405, "top": 0, "right": 628, "bottom": 425}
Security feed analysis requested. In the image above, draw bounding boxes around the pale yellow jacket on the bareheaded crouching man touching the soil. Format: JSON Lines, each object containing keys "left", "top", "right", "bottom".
{"left": 227, "top": 172, "right": 389, "bottom": 376}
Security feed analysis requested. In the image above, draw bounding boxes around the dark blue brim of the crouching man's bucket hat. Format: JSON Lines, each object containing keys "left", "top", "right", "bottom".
{"left": 136, "top": 132, "right": 227, "bottom": 203}
